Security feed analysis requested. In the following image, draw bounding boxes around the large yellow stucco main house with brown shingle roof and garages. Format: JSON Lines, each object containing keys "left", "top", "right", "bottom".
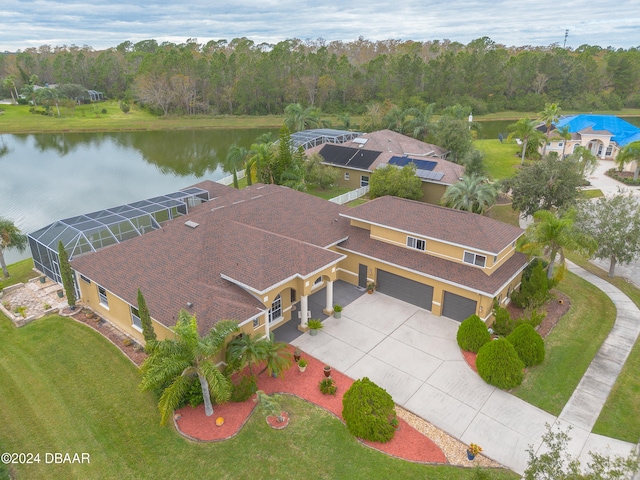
{"left": 51, "top": 181, "right": 527, "bottom": 341}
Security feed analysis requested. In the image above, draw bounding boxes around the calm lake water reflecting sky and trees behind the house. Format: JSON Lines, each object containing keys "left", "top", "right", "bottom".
{"left": 0, "top": 129, "right": 277, "bottom": 264}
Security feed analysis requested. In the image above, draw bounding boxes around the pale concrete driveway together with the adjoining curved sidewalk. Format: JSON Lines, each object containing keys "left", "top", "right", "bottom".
{"left": 293, "top": 266, "right": 640, "bottom": 474}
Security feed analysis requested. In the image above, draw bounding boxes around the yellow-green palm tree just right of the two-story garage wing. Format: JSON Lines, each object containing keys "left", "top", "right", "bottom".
{"left": 519, "top": 209, "right": 596, "bottom": 278}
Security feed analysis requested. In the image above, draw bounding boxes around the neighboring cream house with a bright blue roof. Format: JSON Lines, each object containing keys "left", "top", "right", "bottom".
{"left": 538, "top": 114, "right": 640, "bottom": 170}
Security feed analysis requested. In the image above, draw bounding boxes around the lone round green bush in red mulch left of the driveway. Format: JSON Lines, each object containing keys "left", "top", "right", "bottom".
{"left": 342, "top": 377, "right": 396, "bottom": 442}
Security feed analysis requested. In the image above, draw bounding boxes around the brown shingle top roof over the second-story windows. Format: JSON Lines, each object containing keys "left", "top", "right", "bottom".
{"left": 343, "top": 196, "right": 524, "bottom": 255}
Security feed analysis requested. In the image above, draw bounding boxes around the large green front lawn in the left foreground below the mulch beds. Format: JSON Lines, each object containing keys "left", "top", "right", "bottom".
{"left": 0, "top": 316, "right": 517, "bottom": 479}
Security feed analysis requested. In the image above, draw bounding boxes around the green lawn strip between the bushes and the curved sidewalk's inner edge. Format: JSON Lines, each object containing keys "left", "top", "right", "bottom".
{"left": 513, "top": 272, "right": 616, "bottom": 416}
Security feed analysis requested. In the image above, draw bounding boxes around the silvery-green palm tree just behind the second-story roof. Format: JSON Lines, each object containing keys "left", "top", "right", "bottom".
{"left": 442, "top": 175, "right": 498, "bottom": 214}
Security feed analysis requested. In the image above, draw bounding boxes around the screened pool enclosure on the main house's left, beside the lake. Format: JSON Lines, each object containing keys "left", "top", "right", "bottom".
{"left": 28, "top": 187, "right": 209, "bottom": 283}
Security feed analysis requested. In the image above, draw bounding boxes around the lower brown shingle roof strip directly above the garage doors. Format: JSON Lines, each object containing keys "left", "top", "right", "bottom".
{"left": 338, "top": 227, "right": 528, "bottom": 296}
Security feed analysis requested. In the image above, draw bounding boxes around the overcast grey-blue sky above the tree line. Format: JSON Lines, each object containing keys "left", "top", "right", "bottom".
{"left": 0, "top": 0, "right": 640, "bottom": 52}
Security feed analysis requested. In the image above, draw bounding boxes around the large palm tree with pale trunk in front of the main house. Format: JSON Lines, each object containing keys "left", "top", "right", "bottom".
{"left": 141, "top": 310, "right": 238, "bottom": 424}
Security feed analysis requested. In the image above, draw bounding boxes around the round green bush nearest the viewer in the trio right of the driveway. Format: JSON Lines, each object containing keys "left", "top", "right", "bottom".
{"left": 476, "top": 338, "right": 524, "bottom": 390}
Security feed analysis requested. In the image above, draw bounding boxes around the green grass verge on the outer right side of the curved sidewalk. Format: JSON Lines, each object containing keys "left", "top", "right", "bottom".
{"left": 569, "top": 255, "right": 640, "bottom": 443}
